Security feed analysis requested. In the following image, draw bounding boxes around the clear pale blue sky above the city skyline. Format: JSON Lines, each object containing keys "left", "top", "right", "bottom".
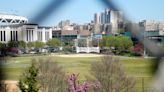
{"left": 0, "top": 0, "right": 164, "bottom": 26}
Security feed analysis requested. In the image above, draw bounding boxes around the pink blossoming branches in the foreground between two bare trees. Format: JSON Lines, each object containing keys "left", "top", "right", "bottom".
{"left": 68, "top": 74, "right": 98, "bottom": 92}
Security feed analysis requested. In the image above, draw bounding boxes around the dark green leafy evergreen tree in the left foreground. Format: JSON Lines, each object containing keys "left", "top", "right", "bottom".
{"left": 18, "top": 60, "right": 40, "bottom": 92}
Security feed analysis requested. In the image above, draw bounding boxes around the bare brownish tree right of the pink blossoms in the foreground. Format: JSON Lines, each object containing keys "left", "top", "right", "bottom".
{"left": 91, "top": 56, "right": 135, "bottom": 92}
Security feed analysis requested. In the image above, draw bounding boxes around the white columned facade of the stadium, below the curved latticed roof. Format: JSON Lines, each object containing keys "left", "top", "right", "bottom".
{"left": 0, "top": 24, "right": 52, "bottom": 43}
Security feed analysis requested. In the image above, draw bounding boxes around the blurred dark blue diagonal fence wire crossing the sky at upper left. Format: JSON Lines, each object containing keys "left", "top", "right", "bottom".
{"left": 31, "top": 0, "right": 69, "bottom": 24}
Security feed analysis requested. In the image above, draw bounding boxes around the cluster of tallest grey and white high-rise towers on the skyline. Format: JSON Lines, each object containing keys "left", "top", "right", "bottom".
{"left": 94, "top": 9, "right": 123, "bottom": 34}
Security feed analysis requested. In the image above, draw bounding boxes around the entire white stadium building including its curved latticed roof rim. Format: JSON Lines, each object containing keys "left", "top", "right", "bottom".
{"left": 0, "top": 14, "right": 52, "bottom": 43}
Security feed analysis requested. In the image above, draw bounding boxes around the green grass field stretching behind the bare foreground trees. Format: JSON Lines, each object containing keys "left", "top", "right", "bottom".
{"left": 1, "top": 55, "right": 154, "bottom": 91}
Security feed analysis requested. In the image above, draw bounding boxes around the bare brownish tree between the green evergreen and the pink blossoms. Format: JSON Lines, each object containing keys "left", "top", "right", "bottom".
{"left": 38, "top": 59, "right": 68, "bottom": 92}
